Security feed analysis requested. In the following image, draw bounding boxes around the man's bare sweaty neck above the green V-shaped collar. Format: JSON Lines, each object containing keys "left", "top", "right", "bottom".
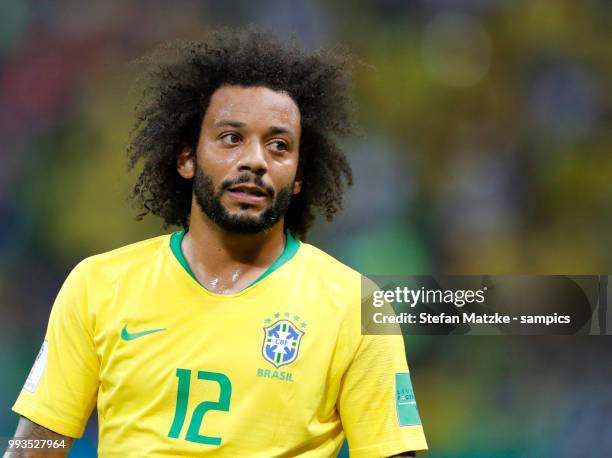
{"left": 181, "top": 200, "right": 285, "bottom": 293}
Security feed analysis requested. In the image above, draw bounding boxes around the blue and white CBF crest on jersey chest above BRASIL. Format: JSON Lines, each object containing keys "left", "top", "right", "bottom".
{"left": 261, "top": 319, "right": 306, "bottom": 369}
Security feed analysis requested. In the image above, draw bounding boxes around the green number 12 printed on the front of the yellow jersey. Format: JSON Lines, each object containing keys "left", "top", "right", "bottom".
{"left": 168, "top": 369, "right": 232, "bottom": 445}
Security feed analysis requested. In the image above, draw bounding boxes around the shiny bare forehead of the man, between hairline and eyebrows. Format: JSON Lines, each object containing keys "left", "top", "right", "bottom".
{"left": 204, "top": 86, "right": 300, "bottom": 129}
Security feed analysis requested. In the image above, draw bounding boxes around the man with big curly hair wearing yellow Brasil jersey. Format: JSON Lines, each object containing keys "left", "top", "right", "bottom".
{"left": 5, "top": 29, "right": 427, "bottom": 457}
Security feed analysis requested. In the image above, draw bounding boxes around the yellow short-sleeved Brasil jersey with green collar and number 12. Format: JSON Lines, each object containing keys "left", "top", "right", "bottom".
{"left": 13, "top": 232, "right": 427, "bottom": 458}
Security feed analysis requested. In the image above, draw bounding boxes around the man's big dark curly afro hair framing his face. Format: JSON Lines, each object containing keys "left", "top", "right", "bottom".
{"left": 128, "top": 27, "right": 353, "bottom": 239}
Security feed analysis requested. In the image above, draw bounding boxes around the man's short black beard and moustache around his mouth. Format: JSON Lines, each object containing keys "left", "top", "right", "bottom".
{"left": 193, "top": 164, "right": 293, "bottom": 234}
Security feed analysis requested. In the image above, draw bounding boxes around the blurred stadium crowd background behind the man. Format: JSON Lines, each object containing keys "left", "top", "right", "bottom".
{"left": 0, "top": 0, "right": 612, "bottom": 458}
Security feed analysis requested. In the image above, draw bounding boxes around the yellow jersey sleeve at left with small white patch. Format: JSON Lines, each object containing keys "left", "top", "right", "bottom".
{"left": 13, "top": 263, "right": 99, "bottom": 438}
